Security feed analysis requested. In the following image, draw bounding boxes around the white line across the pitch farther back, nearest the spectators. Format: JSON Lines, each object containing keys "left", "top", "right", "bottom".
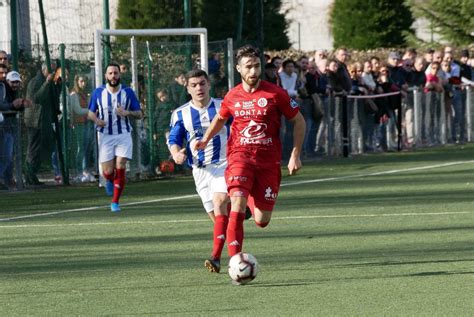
{"left": 0, "top": 160, "right": 474, "bottom": 223}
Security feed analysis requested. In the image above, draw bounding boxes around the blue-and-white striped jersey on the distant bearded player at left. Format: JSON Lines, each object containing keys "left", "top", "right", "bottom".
{"left": 89, "top": 85, "right": 140, "bottom": 134}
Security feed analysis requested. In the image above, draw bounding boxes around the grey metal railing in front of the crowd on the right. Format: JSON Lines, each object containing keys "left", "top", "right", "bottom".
{"left": 315, "top": 86, "right": 474, "bottom": 156}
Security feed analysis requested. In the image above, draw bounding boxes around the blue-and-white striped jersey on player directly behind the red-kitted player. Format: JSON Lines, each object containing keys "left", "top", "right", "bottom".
{"left": 168, "top": 98, "right": 230, "bottom": 168}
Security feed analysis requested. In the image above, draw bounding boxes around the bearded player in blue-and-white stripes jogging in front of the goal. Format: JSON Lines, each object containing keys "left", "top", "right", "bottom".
{"left": 88, "top": 63, "right": 142, "bottom": 212}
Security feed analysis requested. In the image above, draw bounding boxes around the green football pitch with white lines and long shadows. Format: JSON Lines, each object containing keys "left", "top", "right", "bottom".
{"left": 0, "top": 145, "right": 474, "bottom": 316}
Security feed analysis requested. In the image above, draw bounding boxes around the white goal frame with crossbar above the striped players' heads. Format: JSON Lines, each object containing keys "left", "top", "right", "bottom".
{"left": 94, "top": 28, "right": 208, "bottom": 87}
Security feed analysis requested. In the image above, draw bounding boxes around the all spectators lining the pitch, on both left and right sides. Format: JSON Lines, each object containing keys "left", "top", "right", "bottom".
{"left": 0, "top": 46, "right": 474, "bottom": 190}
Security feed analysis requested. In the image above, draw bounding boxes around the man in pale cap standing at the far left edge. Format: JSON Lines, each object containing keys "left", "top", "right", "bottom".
{"left": 0, "top": 68, "right": 31, "bottom": 190}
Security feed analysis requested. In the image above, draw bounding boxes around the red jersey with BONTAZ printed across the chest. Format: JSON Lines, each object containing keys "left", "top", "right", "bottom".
{"left": 219, "top": 80, "right": 299, "bottom": 160}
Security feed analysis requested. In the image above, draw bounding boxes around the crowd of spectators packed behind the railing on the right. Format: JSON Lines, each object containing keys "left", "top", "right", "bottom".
{"left": 264, "top": 46, "right": 473, "bottom": 156}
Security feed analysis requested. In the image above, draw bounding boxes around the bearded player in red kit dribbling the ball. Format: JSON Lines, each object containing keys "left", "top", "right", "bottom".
{"left": 195, "top": 45, "right": 305, "bottom": 257}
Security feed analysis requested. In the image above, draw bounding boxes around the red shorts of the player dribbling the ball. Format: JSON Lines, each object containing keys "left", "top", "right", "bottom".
{"left": 225, "top": 152, "right": 281, "bottom": 211}
